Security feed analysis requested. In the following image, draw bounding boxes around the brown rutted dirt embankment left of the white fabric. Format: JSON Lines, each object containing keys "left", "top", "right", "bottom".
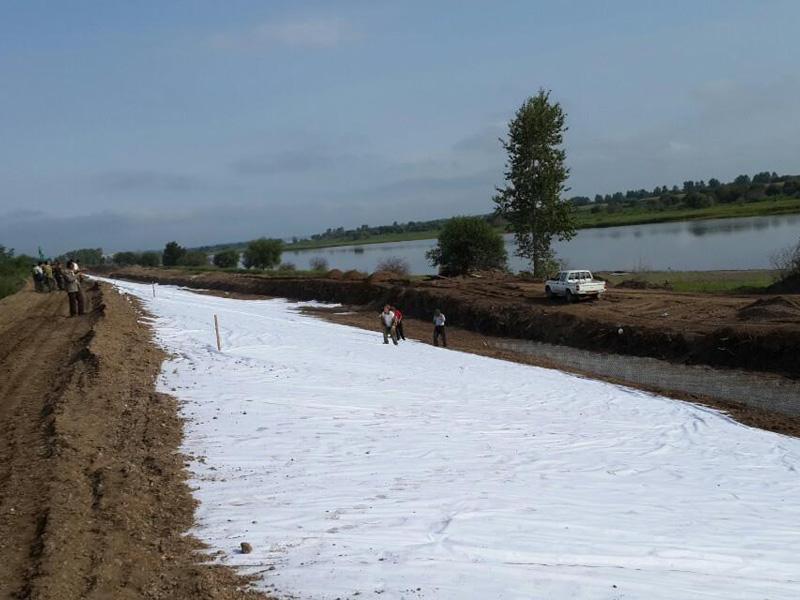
{"left": 0, "top": 287, "right": 270, "bottom": 600}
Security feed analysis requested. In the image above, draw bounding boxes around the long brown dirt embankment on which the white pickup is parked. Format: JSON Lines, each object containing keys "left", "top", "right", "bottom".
{"left": 100, "top": 268, "right": 800, "bottom": 377}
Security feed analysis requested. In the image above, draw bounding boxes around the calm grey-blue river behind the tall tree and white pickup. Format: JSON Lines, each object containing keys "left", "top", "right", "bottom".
{"left": 283, "top": 215, "right": 800, "bottom": 274}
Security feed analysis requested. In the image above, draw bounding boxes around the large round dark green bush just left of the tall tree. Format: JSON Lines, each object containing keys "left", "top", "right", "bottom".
{"left": 425, "top": 217, "right": 507, "bottom": 275}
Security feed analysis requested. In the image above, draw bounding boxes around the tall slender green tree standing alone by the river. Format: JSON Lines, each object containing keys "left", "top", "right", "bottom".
{"left": 494, "top": 90, "right": 575, "bottom": 277}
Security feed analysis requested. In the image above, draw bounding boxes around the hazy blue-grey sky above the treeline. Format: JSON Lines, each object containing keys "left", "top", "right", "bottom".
{"left": 0, "top": 0, "right": 800, "bottom": 254}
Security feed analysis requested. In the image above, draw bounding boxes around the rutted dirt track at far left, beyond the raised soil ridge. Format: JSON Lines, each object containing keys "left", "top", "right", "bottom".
{"left": 0, "top": 290, "right": 91, "bottom": 597}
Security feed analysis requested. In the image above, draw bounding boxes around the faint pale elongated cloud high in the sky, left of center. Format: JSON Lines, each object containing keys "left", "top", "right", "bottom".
{"left": 211, "top": 18, "right": 357, "bottom": 49}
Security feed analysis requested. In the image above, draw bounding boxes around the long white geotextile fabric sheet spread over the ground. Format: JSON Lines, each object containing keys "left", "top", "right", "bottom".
{"left": 106, "top": 282, "right": 800, "bottom": 600}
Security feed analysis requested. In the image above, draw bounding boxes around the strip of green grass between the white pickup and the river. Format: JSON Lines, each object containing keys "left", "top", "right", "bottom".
{"left": 597, "top": 269, "right": 777, "bottom": 294}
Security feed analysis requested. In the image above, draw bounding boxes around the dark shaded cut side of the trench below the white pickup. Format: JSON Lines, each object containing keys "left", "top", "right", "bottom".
{"left": 104, "top": 269, "right": 800, "bottom": 378}
